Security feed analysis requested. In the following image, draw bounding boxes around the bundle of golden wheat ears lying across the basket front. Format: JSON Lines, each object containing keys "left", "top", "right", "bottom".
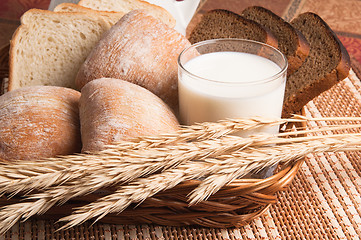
{"left": 0, "top": 116, "right": 361, "bottom": 233}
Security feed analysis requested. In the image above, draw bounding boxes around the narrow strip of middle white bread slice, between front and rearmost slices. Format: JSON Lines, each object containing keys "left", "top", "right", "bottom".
{"left": 54, "top": 3, "right": 125, "bottom": 25}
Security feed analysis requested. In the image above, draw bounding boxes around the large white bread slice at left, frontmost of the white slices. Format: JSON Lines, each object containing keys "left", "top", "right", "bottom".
{"left": 9, "top": 9, "right": 110, "bottom": 90}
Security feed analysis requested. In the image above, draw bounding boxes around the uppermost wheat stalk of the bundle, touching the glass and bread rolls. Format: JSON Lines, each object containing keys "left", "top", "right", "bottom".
{"left": 0, "top": 116, "right": 361, "bottom": 195}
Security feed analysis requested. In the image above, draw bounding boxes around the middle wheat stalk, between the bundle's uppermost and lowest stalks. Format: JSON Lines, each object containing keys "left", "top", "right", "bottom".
{"left": 0, "top": 127, "right": 358, "bottom": 231}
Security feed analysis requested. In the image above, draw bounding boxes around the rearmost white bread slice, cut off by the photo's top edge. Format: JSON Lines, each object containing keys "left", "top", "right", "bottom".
{"left": 78, "top": 0, "right": 176, "bottom": 28}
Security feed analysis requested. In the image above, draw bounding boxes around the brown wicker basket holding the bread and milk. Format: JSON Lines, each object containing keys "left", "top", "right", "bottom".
{"left": 0, "top": 43, "right": 303, "bottom": 228}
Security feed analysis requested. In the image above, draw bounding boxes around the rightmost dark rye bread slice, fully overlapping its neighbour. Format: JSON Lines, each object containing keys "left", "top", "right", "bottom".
{"left": 283, "top": 12, "right": 350, "bottom": 117}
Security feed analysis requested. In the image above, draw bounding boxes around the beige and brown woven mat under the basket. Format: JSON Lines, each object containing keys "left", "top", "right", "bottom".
{"left": 0, "top": 70, "right": 361, "bottom": 240}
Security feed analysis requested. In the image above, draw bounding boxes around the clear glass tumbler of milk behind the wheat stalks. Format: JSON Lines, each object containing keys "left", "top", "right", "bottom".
{"left": 178, "top": 39, "right": 288, "bottom": 135}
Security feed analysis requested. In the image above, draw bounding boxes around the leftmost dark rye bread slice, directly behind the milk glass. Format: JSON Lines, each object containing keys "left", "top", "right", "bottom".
{"left": 189, "top": 9, "right": 278, "bottom": 47}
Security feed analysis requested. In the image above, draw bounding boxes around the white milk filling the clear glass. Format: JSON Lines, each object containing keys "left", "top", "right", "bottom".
{"left": 179, "top": 52, "right": 286, "bottom": 133}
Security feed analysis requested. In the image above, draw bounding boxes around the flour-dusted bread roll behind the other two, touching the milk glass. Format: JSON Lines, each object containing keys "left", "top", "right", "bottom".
{"left": 76, "top": 10, "right": 190, "bottom": 111}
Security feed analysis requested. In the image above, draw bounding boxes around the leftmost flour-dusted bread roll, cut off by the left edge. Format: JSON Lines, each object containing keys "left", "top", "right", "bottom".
{"left": 0, "top": 86, "right": 81, "bottom": 160}
